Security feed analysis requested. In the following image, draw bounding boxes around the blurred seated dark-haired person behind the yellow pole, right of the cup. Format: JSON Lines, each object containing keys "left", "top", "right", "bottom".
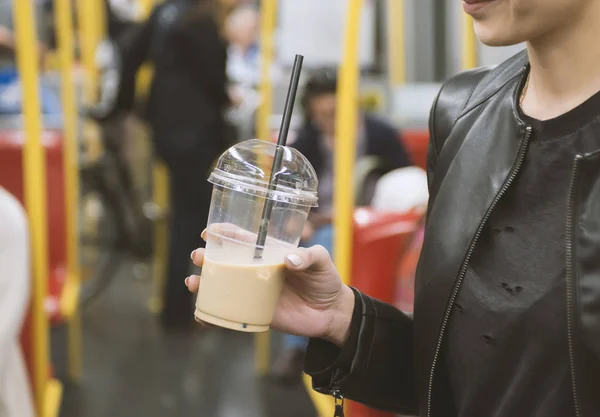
{"left": 272, "top": 69, "right": 412, "bottom": 382}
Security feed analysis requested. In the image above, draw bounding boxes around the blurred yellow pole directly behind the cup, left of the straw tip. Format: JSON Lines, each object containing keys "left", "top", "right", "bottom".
{"left": 254, "top": 0, "right": 278, "bottom": 375}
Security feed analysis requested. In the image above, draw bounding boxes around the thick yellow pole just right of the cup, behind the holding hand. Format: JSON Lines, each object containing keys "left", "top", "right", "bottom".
{"left": 305, "top": 0, "right": 363, "bottom": 417}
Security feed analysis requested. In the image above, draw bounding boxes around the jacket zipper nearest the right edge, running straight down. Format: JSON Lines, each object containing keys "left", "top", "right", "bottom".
{"left": 565, "top": 155, "right": 583, "bottom": 417}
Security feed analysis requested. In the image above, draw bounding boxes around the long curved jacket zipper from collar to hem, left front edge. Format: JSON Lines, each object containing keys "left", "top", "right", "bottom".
{"left": 427, "top": 126, "right": 532, "bottom": 417}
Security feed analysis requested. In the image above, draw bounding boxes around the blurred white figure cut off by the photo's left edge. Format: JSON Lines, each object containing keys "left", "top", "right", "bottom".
{"left": 0, "top": 187, "right": 34, "bottom": 417}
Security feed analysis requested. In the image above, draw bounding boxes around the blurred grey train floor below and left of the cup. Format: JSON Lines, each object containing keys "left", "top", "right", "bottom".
{"left": 52, "top": 265, "right": 316, "bottom": 417}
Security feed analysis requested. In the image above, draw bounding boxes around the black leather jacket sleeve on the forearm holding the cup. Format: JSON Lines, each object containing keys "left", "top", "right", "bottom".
{"left": 305, "top": 290, "right": 417, "bottom": 414}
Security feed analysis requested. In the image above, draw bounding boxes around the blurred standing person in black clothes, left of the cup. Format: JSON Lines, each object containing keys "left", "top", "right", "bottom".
{"left": 121, "top": 0, "right": 229, "bottom": 329}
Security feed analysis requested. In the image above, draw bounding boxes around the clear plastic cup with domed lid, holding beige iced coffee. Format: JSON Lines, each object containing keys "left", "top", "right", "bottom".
{"left": 195, "top": 139, "right": 318, "bottom": 332}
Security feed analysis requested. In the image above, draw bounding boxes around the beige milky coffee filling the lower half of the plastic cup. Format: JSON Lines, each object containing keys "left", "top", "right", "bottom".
{"left": 195, "top": 251, "right": 284, "bottom": 332}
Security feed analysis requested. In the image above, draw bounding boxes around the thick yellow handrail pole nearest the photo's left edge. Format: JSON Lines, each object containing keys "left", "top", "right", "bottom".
{"left": 13, "top": 1, "right": 61, "bottom": 417}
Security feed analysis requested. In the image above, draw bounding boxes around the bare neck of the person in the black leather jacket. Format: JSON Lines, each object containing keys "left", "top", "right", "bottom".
{"left": 523, "top": 2, "right": 600, "bottom": 120}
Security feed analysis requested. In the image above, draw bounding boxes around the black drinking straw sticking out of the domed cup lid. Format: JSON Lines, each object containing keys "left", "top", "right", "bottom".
{"left": 254, "top": 55, "right": 304, "bottom": 259}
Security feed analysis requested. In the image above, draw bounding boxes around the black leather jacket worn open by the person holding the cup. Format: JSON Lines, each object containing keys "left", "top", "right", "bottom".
{"left": 307, "top": 53, "right": 600, "bottom": 417}
